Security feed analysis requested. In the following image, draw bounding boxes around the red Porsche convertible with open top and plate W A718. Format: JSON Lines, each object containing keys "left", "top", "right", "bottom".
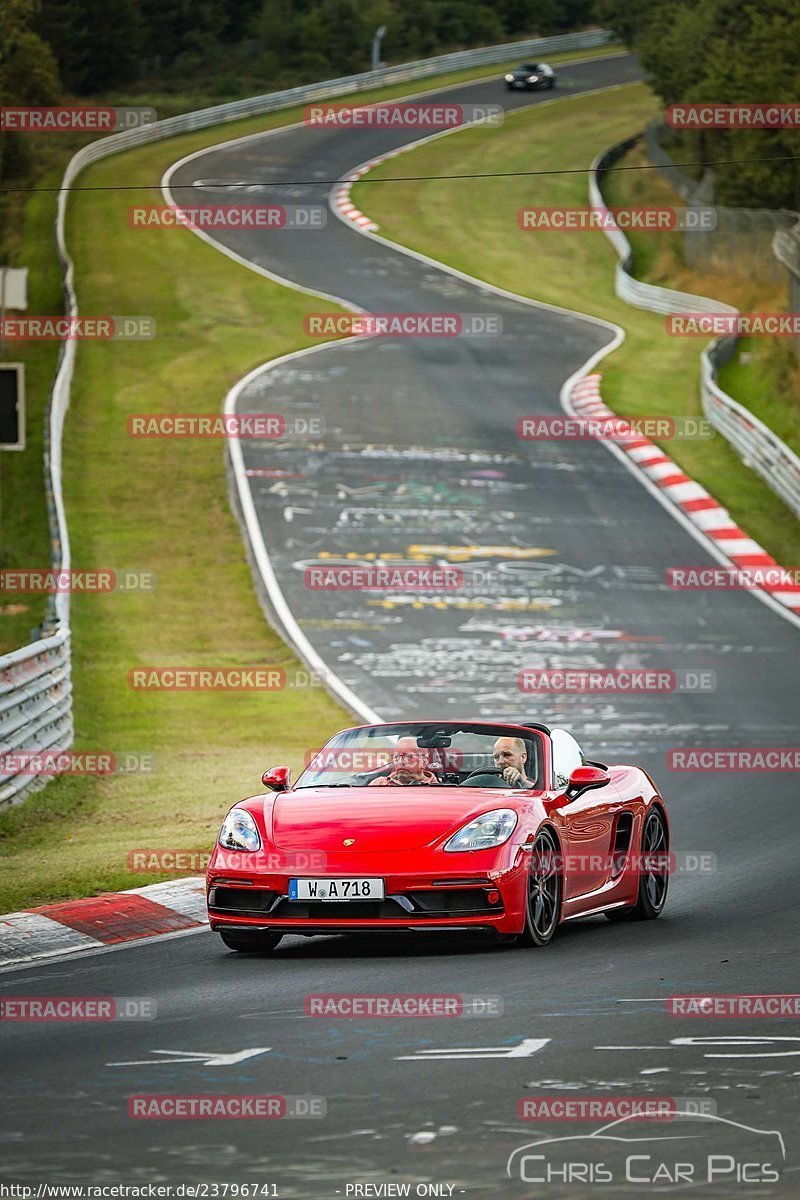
{"left": 207, "top": 720, "right": 669, "bottom": 953}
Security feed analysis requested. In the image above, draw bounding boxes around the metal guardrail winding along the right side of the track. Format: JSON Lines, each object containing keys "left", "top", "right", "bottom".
{"left": 589, "top": 134, "right": 800, "bottom": 516}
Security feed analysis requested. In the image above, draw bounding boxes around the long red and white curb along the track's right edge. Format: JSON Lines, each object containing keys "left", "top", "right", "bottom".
{"left": 570, "top": 374, "right": 800, "bottom": 613}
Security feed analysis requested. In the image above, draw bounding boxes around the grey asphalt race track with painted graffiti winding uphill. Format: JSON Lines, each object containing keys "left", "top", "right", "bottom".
{"left": 0, "top": 56, "right": 800, "bottom": 1200}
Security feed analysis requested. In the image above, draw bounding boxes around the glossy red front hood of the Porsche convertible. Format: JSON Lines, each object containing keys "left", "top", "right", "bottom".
{"left": 265, "top": 787, "right": 519, "bottom": 852}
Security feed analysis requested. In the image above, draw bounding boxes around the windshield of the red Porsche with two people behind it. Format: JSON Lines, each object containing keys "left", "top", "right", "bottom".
{"left": 295, "top": 721, "right": 542, "bottom": 790}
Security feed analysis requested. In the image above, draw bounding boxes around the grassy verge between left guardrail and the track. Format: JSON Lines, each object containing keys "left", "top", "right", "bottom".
{"left": 0, "top": 44, "right": 623, "bottom": 912}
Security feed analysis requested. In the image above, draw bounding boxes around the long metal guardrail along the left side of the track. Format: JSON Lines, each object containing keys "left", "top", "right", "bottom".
{"left": 0, "top": 29, "right": 612, "bottom": 808}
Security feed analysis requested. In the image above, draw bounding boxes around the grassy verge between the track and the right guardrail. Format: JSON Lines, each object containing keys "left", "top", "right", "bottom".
{"left": 353, "top": 84, "right": 800, "bottom": 565}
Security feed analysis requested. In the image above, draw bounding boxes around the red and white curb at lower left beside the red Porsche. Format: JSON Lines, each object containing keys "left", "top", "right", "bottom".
{"left": 0, "top": 877, "right": 207, "bottom": 967}
